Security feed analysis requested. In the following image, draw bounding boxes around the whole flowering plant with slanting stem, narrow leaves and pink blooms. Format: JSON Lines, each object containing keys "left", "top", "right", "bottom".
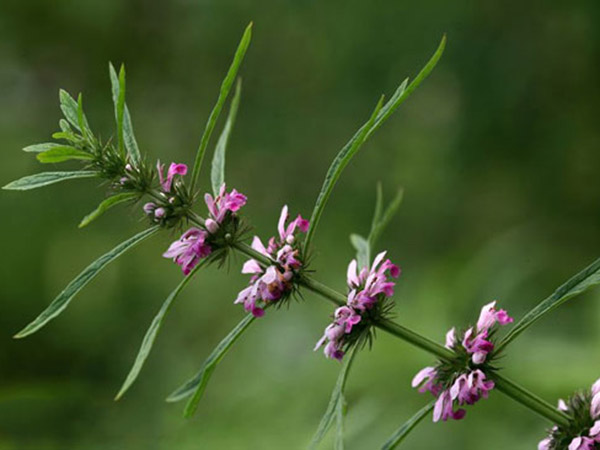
{"left": 4, "top": 24, "right": 600, "bottom": 450}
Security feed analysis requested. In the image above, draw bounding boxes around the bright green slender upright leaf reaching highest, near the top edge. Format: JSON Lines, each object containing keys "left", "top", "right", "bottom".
{"left": 190, "top": 22, "right": 252, "bottom": 191}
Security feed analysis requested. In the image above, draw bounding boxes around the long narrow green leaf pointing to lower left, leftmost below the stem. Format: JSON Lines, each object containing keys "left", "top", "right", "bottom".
{"left": 14, "top": 226, "right": 160, "bottom": 339}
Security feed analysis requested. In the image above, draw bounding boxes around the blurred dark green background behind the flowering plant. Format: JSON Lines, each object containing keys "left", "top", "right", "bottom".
{"left": 0, "top": 0, "right": 600, "bottom": 450}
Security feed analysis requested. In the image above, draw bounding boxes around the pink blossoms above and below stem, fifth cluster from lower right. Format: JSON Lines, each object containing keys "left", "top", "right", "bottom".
{"left": 162, "top": 182, "right": 246, "bottom": 275}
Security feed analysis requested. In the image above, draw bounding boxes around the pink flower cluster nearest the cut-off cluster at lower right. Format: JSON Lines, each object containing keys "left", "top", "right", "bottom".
{"left": 412, "top": 302, "right": 513, "bottom": 422}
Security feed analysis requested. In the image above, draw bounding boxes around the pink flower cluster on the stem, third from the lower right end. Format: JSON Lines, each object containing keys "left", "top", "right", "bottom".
{"left": 315, "top": 252, "right": 400, "bottom": 361}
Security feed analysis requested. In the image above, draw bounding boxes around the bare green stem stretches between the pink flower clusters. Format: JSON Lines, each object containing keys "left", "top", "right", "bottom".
{"left": 233, "top": 243, "right": 569, "bottom": 426}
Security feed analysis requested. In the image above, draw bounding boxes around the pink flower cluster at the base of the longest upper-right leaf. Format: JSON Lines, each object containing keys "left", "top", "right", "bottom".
{"left": 234, "top": 207, "right": 309, "bottom": 317}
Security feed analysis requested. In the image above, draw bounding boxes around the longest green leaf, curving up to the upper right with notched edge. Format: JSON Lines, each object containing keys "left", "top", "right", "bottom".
{"left": 305, "top": 36, "right": 446, "bottom": 247}
